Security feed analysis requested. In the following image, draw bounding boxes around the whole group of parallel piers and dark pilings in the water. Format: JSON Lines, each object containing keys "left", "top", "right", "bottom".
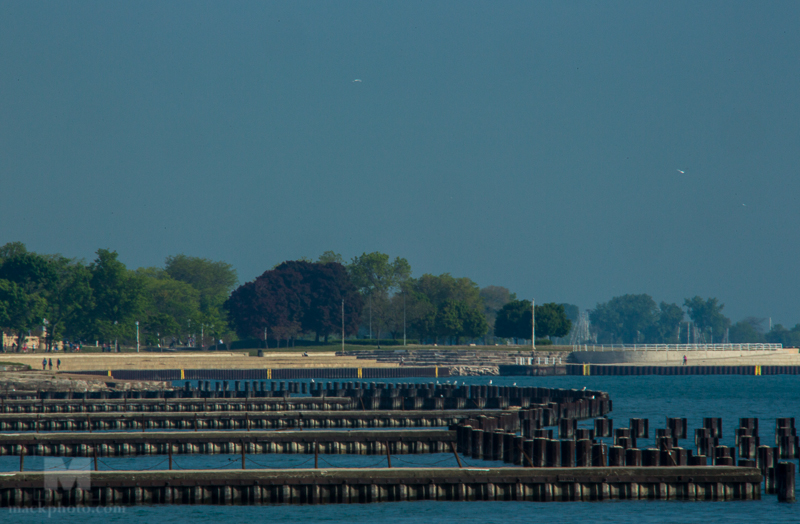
{"left": 0, "top": 381, "right": 800, "bottom": 508}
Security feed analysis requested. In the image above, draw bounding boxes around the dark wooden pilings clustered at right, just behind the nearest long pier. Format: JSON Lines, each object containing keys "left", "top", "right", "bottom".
{"left": 456, "top": 417, "right": 798, "bottom": 500}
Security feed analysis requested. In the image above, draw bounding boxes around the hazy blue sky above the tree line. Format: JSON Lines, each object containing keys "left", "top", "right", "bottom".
{"left": 0, "top": 1, "right": 800, "bottom": 325}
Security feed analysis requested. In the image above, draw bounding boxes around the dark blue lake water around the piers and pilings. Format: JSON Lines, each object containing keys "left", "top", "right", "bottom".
{"left": 0, "top": 375, "right": 800, "bottom": 524}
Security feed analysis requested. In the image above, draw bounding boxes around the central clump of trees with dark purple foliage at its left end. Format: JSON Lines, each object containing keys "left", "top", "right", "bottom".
{"left": 225, "top": 251, "right": 569, "bottom": 344}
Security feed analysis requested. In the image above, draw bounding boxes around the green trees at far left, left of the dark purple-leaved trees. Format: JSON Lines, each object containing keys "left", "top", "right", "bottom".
{"left": 0, "top": 242, "right": 238, "bottom": 347}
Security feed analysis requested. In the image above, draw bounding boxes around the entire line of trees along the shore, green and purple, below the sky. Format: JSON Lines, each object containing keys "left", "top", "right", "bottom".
{"left": 0, "top": 242, "right": 800, "bottom": 346}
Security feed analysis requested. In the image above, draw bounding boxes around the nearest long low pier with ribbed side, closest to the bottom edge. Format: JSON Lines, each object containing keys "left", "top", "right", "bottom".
{"left": 0, "top": 467, "right": 761, "bottom": 507}
